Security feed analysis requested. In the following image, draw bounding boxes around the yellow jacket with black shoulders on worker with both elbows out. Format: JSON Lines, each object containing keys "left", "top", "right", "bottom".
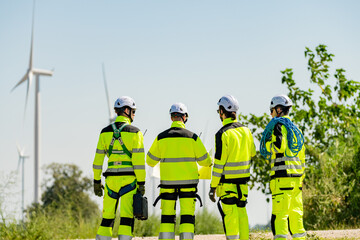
{"left": 146, "top": 121, "right": 211, "bottom": 187}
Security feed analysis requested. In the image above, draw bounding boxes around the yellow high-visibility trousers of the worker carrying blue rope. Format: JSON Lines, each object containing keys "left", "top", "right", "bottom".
{"left": 270, "top": 177, "right": 306, "bottom": 239}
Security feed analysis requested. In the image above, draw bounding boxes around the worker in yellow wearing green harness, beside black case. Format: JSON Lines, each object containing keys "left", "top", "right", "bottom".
{"left": 93, "top": 96, "right": 145, "bottom": 240}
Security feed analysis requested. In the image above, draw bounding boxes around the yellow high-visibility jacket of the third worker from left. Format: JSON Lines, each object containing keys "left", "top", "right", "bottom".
{"left": 210, "top": 118, "right": 256, "bottom": 187}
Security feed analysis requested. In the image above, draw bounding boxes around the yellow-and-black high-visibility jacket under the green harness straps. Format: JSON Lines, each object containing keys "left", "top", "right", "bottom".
{"left": 93, "top": 116, "right": 146, "bottom": 184}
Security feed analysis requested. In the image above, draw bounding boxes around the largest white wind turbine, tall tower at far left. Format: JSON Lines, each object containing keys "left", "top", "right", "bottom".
{"left": 11, "top": 1, "right": 53, "bottom": 203}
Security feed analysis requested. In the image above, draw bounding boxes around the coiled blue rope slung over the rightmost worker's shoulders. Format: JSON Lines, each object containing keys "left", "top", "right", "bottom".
{"left": 260, "top": 117, "right": 304, "bottom": 160}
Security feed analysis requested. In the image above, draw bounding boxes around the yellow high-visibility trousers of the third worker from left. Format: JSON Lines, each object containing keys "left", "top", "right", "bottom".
{"left": 216, "top": 183, "right": 249, "bottom": 240}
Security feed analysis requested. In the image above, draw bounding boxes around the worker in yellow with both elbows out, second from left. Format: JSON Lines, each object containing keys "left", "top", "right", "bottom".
{"left": 146, "top": 103, "right": 211, "bottom": 240}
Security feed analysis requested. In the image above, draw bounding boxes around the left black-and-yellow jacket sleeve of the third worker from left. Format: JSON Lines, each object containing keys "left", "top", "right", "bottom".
{"left": 210, "top": 132, "right": 228, "bottom": 187}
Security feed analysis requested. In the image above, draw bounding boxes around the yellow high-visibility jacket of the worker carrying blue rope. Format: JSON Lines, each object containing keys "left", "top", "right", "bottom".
{"left": 266, "top": 116, "right": 305, "bottom": 179}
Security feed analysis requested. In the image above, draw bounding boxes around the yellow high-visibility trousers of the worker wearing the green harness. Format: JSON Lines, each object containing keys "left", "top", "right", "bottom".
{"left": 96, "top": 176, "right": 136, "bottom": 240}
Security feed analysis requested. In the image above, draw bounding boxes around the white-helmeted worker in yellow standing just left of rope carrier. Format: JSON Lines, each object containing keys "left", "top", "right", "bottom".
{"left": 209, "top": 95, "right": 256, "bottom": 240}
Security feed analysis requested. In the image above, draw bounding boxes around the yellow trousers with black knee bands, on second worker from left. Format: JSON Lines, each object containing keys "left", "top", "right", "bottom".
{"left": 159, "top": 188, "right": 196, "bottom": 240}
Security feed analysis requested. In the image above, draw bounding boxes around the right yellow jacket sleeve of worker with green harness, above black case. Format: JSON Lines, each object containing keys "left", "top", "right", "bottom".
{"left": 132, "top": 131, "right": 146, "bottom": 185}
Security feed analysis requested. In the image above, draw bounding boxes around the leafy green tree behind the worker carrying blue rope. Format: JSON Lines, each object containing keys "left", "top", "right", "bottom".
{"left": 239, "top": 45, "right": 360, "bottom": 228}
